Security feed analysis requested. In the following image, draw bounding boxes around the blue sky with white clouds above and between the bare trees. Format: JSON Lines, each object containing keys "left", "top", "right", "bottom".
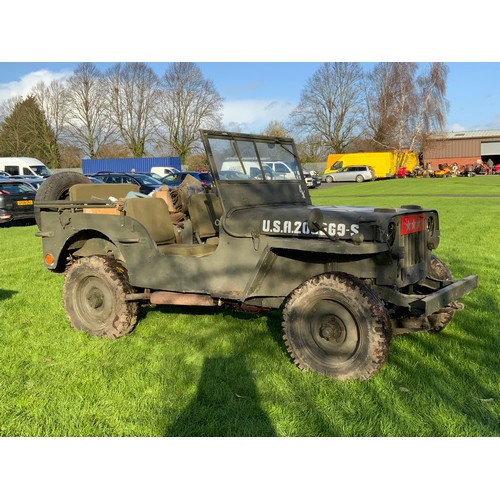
{"left": 0, "top": 62, "right": 500, "bottom": 133}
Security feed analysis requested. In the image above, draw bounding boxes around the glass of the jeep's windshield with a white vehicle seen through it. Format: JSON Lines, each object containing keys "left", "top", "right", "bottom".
{"left": 209, "top": 138, "right": 301, "bottom": 182}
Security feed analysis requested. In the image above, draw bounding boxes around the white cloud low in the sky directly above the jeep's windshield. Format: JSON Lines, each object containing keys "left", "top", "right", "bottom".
{"left": 223, "top": 99, "right": 296, "bottom": 133}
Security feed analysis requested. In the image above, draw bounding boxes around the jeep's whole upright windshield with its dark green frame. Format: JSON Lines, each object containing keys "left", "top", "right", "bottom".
{"left": 200, "top": 130, "right": 311, "bottom": 211}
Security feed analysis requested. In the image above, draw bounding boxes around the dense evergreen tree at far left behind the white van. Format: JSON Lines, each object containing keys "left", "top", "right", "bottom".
{"left": 0, "top": 95, "right": 59, "bottom": 168}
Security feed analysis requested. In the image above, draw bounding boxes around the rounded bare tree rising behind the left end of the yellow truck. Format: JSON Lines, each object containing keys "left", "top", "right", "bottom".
{"left": 291, "top": 62, "right": 363, "bottom": 153}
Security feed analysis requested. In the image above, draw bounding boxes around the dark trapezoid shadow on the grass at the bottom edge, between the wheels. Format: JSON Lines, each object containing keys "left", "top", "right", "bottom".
{"left": 165, "top": 356, "right": 276, "bottom": 437}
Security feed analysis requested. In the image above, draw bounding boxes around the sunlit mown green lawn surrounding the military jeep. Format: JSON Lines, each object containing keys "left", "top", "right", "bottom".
{"left": 0, "top": 177, "right": 500, "bottom": 437}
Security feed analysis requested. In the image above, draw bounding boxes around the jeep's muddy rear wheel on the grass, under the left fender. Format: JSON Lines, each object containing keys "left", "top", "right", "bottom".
{"left": 63, "top": 256, "right": 138, "bottom": 339}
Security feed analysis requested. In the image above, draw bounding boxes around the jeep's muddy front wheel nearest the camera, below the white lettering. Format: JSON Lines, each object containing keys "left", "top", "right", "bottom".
{"left": 283, "top": 273, "right": 391, "bottom": 380}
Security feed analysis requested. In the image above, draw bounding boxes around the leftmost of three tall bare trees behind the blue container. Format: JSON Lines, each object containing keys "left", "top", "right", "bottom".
{"left": 66, "top": 63, "right": 116, "bottom": 158}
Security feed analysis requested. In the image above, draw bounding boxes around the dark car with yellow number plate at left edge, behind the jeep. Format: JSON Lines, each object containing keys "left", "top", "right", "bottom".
{"left": 0, "top": 180, "right": 36, "bottom": 224}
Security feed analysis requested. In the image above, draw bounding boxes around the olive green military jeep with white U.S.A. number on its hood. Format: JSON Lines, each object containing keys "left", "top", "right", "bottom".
{"left": 35, "top": 130, "right": 477, "bottom": 380}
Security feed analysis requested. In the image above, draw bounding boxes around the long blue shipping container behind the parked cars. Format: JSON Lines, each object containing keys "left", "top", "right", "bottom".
{"left": 82, "top": 156, "right": 181, "bottom": 175}
